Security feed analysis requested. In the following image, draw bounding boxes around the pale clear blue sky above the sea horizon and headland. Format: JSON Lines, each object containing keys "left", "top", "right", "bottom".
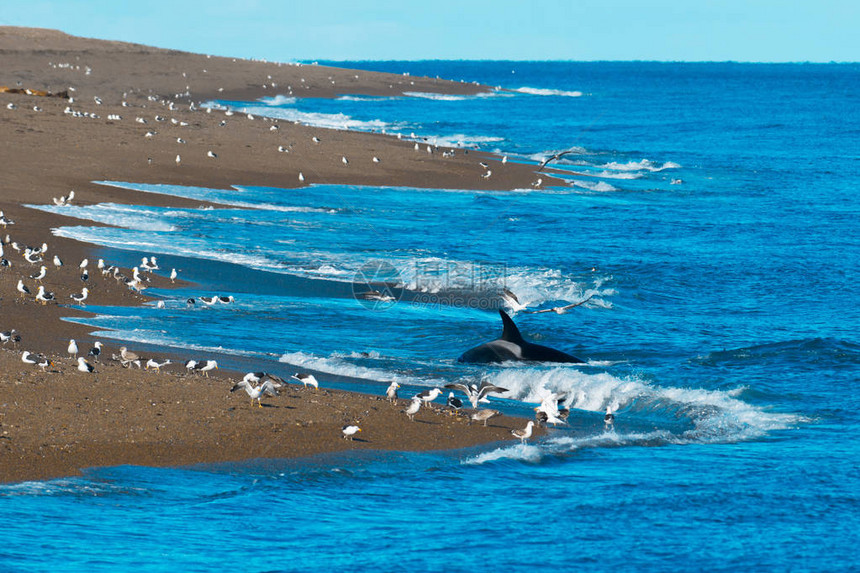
{"left": 0, "top": 0, "right": 860, "bottom": 61}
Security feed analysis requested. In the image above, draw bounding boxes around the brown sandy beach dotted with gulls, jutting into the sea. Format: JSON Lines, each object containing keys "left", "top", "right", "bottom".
{"left": 0, "top": 27, "right": 550, "bottom": 481}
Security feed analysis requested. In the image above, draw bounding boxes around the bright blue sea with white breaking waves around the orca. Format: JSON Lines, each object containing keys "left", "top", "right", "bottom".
{"left": 0, "top": 62, "right": 860, "bottom": 571}
